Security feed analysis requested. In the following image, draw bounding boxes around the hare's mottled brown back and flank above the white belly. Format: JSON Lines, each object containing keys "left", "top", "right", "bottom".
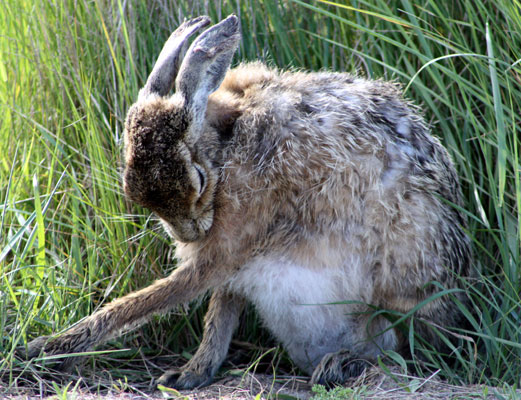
{"left": 208, "top": 64, "right": 470, "bottom": 322}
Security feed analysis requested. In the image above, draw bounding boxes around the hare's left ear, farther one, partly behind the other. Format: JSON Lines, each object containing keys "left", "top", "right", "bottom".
{"left": 139, "top": 16, "right": 210, "bottom": 99}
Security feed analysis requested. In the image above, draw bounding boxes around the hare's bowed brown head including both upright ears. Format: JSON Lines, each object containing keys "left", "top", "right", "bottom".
{"left": 123, "top": 15, "right": 240, "bottom": 242}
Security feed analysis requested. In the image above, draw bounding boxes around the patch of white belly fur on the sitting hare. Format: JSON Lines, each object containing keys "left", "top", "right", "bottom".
{"left": 224, "top": 255, "right": 382, "bottom": 373}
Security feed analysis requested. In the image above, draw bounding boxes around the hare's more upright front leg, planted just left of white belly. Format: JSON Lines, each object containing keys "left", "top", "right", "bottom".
{"left": 158, "top": 288, "right": 244, "bottom": 389}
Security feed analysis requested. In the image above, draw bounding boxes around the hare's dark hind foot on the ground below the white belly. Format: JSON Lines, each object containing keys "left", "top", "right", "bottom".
{"left": 311, "top": 350, "right": 370, "bottom": 387}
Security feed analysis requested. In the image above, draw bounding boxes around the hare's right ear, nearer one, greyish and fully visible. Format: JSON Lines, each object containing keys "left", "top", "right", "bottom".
{"left": 175, "top": 15, "right": 240, "bottom": 140}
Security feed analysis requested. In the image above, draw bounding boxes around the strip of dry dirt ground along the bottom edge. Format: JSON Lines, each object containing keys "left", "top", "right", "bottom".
{"left": 0, "top": 367, "right": 521, "bottom": 400}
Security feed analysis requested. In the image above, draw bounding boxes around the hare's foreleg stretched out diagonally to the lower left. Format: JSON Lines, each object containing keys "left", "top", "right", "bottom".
{"left": 26, "top": 265, "right": 222, "bottom": 370}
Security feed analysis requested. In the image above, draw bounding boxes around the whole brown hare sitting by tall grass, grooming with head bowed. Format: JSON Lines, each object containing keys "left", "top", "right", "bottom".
{"left": 27, "top": 15, "right": 472, "bottom": 389}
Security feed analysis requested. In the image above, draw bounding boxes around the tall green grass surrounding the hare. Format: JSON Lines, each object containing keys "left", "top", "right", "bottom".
{"left": 0, "top": 0, "right": 521, "bottom": 394}
